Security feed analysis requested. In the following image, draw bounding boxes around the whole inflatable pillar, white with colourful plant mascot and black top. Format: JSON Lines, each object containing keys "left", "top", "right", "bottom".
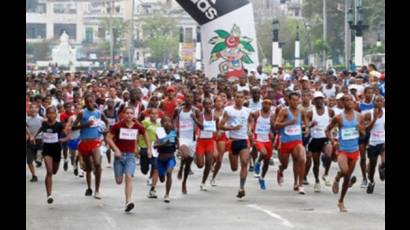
{"left": 177, "top": 0, "right": 258, "bottom": 80}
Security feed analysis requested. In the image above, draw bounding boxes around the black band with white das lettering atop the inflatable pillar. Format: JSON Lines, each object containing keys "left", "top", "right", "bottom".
{"left": 176, "top": 0, "right": 249, "bottom": 25}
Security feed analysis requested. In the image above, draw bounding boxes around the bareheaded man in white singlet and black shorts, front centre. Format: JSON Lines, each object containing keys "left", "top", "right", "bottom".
{"left": 220, "top": 91, "right": 253, "bottom": 198}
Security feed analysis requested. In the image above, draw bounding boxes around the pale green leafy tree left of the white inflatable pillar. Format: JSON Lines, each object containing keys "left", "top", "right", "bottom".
{"left": 142, "top": 15, "right": 179, "bottom": 63}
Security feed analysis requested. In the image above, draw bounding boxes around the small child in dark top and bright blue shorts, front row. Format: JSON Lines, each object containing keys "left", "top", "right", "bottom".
{"left": 154, "top": 116, "right": 178, "bottom": 203}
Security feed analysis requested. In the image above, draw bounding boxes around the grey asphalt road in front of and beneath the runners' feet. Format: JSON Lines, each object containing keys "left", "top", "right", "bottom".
{"left": 26, "top": 156, "right": 385, "bottom": 230}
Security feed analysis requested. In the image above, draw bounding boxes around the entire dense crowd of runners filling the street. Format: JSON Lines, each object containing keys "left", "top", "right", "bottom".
{"left": 26, "top": 65, "right": 385, "bottom": 212}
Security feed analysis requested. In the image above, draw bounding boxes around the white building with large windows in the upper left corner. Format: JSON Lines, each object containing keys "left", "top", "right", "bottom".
{"left": 26, "top": 0, "right": 87, "bottom": 44}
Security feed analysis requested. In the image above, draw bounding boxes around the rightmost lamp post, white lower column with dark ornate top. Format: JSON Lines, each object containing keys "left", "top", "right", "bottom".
{"left": 348, "top": 0, "right": 369, "bottom": 67}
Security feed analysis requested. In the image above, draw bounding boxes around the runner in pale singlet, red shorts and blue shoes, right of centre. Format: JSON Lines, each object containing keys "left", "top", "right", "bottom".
{"left": 252, "top": 98, "right": 275, "bottom": 190}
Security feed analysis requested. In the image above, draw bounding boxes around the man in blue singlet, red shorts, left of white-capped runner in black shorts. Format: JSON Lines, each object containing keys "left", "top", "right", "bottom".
{"left": 275, "top": 92, "right": 309, "bottom": 195}
